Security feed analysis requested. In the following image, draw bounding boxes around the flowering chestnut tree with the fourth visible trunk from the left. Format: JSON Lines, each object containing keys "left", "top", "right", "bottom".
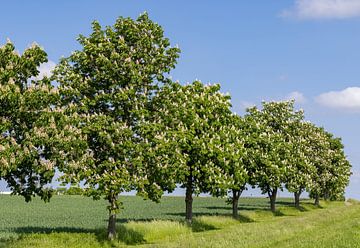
{"left": 245, "top": 101, "right": 303, "bottom": 211}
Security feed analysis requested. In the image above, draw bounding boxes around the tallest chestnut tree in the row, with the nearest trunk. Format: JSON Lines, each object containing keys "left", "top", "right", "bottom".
{"left": 50, "top": 13, "right": 179, "bottom": 239}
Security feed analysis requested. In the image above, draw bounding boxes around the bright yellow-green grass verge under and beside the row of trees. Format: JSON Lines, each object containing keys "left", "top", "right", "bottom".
{"left": 0, "top": 197, "right": 360, "bottom": 248}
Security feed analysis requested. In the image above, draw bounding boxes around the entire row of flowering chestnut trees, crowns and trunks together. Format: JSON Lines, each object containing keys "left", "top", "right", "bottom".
{"left": 0, "top": 14, "right": 351, "bottom": 239}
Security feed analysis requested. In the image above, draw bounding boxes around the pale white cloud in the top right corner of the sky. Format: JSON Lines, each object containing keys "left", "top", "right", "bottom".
{"left": 281, "top": 0, "right": 360, "bottom": 19}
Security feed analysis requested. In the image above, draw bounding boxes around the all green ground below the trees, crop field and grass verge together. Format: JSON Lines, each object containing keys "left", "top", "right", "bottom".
{"left": 0, "top": 195, "right": 360, "bottom": 248}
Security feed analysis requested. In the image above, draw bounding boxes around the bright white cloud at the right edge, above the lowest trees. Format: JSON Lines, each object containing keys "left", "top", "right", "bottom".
{"left": 315, "top": 87, "right": 360, "bottom": 111}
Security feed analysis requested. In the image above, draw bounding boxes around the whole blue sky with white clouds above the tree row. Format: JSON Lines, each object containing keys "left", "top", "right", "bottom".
{"left": 0, "top": 0, "right": 360, "bottom": 199}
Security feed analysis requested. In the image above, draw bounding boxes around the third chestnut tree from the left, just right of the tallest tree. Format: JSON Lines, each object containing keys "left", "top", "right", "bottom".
{"left": 153, "top": 81, "right": 236, "bottom": 223}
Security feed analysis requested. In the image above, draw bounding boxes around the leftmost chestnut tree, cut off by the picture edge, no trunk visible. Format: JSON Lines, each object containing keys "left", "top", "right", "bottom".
{"left": 0, "top": 41, "right": 57, "bottom": 201}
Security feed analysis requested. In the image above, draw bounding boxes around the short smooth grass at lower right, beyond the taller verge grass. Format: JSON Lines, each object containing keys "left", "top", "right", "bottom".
{"left": 154, "top": 201, "right": 360, "bottom": 248}
